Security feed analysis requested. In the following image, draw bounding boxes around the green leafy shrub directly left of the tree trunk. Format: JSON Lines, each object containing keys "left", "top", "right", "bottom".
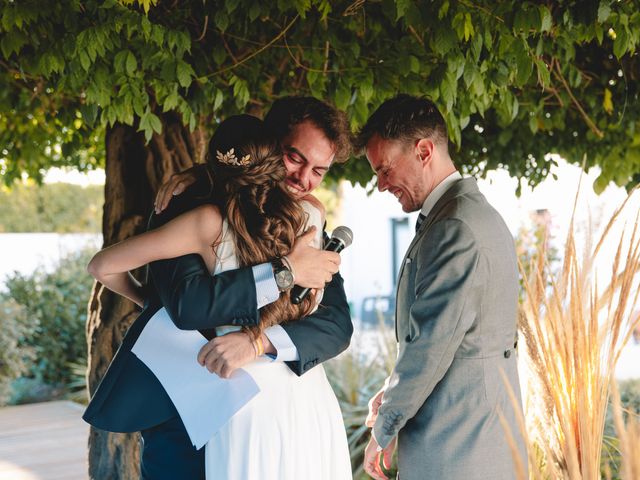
{"left": 0, "top": 251, "right": 93, "bottom": 385}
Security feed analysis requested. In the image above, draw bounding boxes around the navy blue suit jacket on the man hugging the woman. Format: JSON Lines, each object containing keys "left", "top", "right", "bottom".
{"left": 83, "top": 193, "right": 353, "bottom": 432}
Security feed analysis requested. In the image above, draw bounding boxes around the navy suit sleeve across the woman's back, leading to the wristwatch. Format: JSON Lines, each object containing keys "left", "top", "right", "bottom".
{"left": 149, "top": 194, "right": 259, "bottom": 330}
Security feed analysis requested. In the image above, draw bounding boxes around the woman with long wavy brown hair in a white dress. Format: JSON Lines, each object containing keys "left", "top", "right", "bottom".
{"left": 88, "top": 115, "right": 351, "bottom": 480}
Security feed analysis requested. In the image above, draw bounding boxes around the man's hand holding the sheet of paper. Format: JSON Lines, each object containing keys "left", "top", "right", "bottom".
{"left": 198, "top": 332, "right": 256, "bottom": 378}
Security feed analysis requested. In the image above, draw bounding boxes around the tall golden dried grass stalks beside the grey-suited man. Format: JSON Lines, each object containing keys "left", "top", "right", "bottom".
{"left": 519, "top": 187, "right": 640, "bottom": 480}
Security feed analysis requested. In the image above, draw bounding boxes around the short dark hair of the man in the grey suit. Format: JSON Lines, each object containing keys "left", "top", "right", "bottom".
{"left": 354, "top": 94, "right": 449, "bottom": 152}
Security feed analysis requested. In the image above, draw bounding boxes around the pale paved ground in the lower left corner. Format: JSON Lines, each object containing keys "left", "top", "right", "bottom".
{"left": 0, "top": 401, "right": 89, "bottom": 480}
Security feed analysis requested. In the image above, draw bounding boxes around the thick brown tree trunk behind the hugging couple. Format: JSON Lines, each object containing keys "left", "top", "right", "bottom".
{"left": 87, "top": 114, "right": 205, "bottom": 480}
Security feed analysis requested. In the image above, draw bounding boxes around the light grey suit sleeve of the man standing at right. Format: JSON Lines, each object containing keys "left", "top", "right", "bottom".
{"left": 373, "top": 219, "right": 479, "bottom": 448}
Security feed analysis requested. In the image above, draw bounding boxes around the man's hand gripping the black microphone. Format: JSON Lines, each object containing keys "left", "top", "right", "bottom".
{"left": 287, "top": 227, "right": 340, "bottom": 289}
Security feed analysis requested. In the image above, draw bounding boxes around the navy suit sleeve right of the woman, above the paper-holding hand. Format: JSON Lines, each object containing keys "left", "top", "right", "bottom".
{"left": 282, "top": 273, "right": 353, "bottom": 375}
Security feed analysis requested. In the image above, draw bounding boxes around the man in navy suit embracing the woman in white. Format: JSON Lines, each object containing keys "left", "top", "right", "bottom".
{"left": 83, "top": 97, "right": 353, "bottom": 480}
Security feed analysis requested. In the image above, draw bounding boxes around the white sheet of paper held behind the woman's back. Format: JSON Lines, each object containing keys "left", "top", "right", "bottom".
{"left": 132, "top": 308, "right": 260, "bottom": 449}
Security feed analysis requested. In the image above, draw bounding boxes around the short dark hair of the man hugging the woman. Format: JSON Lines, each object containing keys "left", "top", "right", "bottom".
{"left": 264, "top": 96, "right": 352, "bottom": 163}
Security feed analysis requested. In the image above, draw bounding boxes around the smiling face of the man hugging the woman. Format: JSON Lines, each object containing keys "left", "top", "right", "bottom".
{"left": 281, "top": 120, "right": 335, "bottom": 198}
